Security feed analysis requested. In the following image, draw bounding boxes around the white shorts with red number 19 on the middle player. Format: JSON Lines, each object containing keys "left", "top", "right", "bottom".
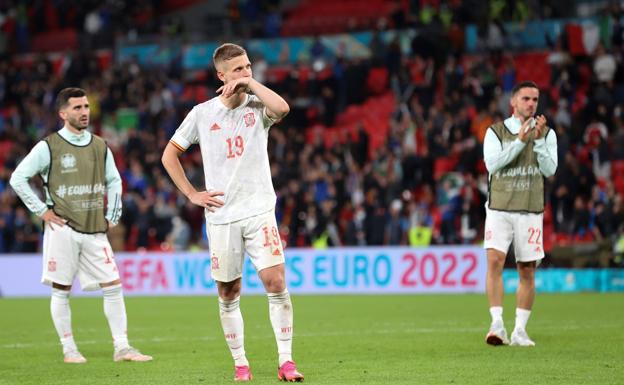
{"left": 206, "top": 210, "right": 284, "bottom": 282}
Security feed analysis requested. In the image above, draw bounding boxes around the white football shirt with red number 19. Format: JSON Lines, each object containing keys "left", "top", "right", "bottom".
{"left": 171, "top": 95, "right": 276, "bottom": 224}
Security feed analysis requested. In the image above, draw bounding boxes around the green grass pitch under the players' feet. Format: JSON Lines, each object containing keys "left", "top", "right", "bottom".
{"left": 0, "top": 293, "right": 624, "bottom": 385}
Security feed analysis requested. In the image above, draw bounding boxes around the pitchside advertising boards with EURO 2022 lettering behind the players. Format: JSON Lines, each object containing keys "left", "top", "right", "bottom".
{"left": 0, "top": 246, "right": 624, "bottom": 297}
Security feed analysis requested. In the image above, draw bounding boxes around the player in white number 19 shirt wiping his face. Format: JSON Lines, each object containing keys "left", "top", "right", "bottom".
{"left": 162, "top": 44, "right": 303, "bottom": 382}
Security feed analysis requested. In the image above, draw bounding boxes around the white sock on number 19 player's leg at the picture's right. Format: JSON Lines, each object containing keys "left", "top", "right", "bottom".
{"left": 267, "top": 290, "right": 293, "bottom": 366}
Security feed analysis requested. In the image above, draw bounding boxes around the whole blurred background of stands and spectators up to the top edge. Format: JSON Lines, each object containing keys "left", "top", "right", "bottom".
{"left": 0, "top": 0, "right": 624, "bottom": 265}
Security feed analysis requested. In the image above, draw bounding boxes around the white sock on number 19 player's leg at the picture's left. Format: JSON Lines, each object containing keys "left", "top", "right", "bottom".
{"left": 219, "top": 296, "right": 249, "bottom": 366}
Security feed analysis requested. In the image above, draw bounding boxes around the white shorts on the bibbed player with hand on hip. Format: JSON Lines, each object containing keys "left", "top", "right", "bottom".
{"left": 41, "top": 224, "right": 119, "bottom": 290}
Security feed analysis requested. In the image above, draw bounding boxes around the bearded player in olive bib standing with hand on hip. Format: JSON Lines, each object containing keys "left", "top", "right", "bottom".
{"left": 10, "top": 88, "right": 152, "bottom": 364}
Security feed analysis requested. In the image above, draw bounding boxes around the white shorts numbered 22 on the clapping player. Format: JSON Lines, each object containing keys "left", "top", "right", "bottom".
{"left": 483, "top": 206, "right": 544, "bottom": 262}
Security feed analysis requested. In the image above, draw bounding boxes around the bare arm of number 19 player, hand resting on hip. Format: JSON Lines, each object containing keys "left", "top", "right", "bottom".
{"left": 161, "top": 143, "right": 223, "bottom": 212}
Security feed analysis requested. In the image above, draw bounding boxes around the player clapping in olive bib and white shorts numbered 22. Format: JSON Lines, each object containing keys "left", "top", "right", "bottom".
{"left": 483, "top": 81, "right": 557, "bottom": 346}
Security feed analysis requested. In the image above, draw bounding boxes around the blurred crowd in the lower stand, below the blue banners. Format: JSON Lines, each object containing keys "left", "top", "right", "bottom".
{"left": 0, "top": 2, "right": 624, "bottom": 264}
